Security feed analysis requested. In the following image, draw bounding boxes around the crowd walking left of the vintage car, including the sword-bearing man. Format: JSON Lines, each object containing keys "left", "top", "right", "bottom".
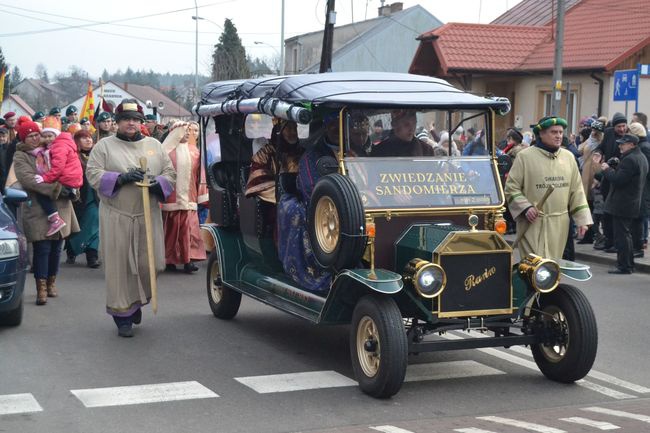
{"left": 0, "top": 100, "right": 207, "bottom": 337}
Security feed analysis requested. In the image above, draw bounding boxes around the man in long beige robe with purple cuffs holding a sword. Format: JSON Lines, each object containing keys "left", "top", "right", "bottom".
{"left": 86, "top": 100, "right": 176, "bottom": 337}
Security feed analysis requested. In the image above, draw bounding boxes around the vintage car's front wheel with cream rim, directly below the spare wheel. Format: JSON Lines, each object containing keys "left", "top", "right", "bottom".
{"left": 350, "top": 295, "right": 408, "bottom": 398}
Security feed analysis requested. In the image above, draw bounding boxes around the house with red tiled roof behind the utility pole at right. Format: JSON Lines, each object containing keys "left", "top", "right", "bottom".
{"left": 409, "top": 0, "right": 650, "bottom": 137}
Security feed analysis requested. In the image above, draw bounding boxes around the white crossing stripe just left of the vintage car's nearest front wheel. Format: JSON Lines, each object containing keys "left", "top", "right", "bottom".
{"left": 235, "top": 371, "right": 357, "bottom": 394}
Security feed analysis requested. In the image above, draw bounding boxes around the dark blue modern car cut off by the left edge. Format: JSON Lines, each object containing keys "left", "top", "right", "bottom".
{"left": 0, "top": 188, "right": 28, "bottom": 326}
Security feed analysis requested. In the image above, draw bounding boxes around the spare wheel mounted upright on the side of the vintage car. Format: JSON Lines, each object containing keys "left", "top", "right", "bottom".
{"left": 307, "top": 173, "right": 366, "bottom": 270}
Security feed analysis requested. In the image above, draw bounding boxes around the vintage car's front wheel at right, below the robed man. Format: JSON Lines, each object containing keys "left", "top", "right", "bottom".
{"left": 531, "top": 284, "right": 598, "bottom": 383}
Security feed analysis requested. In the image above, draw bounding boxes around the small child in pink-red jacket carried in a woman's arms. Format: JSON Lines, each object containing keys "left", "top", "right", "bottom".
{"left": 32, "top": 128, "right": 83, "bottom": 236}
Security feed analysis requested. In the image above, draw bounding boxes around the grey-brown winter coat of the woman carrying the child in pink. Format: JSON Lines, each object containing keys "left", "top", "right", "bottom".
{"left": 14, "top": 143, "right": 79, "bottom": 242}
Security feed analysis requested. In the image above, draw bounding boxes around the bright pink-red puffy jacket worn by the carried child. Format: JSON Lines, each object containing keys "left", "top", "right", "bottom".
{"left": 43, "top": 132, "right": 83, "bottom": 188}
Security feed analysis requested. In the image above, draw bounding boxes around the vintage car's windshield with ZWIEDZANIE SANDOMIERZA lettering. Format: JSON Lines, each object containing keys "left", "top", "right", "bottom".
{"left": 344, "top": 110, "right": 503, "bottom": 210}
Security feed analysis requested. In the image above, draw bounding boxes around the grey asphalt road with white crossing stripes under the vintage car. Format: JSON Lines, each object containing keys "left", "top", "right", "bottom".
{"left": 0, "top": 258, "right": 650, "bottom": 433}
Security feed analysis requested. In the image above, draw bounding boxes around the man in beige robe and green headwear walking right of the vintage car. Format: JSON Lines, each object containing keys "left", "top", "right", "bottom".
{"left": 505, "top": 117, "right": 593, "bottom": 259}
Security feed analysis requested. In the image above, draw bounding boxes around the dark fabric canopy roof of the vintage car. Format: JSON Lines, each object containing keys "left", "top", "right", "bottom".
{"left": 193, "top": 72, "right": 510, "bottom": 123}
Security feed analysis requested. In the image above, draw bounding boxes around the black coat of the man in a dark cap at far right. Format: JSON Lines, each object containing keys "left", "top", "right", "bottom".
{"left": 603, "top": 147, "right": 648, "bottom": 218}
